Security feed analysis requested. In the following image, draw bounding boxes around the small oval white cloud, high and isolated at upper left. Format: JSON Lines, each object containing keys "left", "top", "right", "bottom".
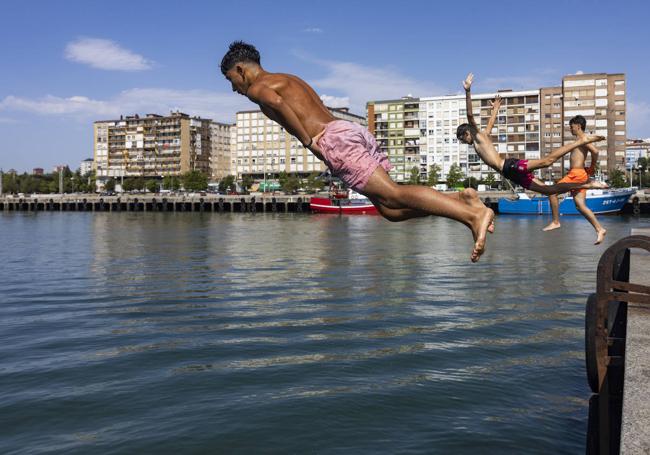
{"left": 65, "top": 38, "right": 153, "bottom": 71}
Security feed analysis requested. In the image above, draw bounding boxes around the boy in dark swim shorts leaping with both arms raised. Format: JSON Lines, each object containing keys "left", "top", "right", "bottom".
{"left": 456, "top": 73, "right": 607, "bottom": 195}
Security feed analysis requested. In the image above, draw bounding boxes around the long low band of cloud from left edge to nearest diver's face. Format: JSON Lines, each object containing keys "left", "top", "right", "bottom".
{"left": 0, "top": 88, "right": 251, "bottom": 122}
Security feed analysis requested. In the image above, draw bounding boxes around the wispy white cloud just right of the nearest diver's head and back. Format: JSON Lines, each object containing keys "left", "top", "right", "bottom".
{"left": 295, "top": 52, "right": 449, "bottom": 115}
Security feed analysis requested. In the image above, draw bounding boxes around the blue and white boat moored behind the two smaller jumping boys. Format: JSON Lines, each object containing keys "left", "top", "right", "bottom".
{"left": 499, "top": 188, "right": 636, "bottom": 215}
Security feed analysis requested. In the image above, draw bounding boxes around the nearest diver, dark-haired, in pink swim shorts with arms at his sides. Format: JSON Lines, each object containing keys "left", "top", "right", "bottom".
{"left": 221, "top": 41, "right": 494, "bottom": 262}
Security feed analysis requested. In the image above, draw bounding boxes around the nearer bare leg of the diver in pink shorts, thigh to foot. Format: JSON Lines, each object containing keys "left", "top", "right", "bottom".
{"left": 362, "top": 167, "right": 494, "bottom": 262}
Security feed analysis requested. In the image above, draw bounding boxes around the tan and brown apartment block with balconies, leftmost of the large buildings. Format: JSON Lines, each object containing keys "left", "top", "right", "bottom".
{"left": 94, "top": 112, "right": 212, "bottom": 181}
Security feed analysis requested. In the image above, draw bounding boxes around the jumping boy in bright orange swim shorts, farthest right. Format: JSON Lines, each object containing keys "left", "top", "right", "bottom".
{"left": 543, "top": 115, "right": 607, "bottom": 245}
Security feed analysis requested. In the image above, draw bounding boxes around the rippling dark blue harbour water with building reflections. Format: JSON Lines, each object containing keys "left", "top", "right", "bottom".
{"left": 0, "top": 213, "right": 648, "bottom": 454}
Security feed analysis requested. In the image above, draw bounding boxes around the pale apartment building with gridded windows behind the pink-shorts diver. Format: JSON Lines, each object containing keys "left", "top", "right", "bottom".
{"left": 231, "top": 108, "right": 366, "bottom": 179}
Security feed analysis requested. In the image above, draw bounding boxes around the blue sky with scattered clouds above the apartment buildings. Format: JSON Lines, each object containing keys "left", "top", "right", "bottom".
{"left": 0, "top": 0, "right": 650, "bottom": 172}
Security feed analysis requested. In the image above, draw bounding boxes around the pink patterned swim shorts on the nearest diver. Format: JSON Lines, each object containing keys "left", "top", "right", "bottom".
{"left": 317, "top": 120, "right": 392, "bottom": 191}
